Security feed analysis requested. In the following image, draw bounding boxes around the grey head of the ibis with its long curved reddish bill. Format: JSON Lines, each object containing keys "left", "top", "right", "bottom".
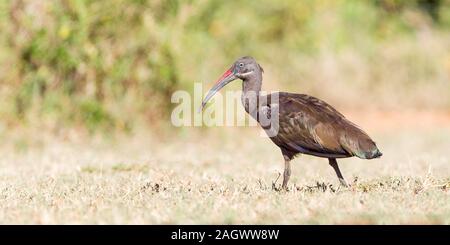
{"left": 200, "top": 56, "right": 264, "bottom": 110}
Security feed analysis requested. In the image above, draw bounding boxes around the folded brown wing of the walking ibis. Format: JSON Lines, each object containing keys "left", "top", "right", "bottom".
{"left": 277, "top": 93, "right": 348, "bottom": 157}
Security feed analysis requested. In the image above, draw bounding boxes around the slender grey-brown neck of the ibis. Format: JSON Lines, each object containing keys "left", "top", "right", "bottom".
{"left": 241, "top": 75, "right": 262, "bottom": 115}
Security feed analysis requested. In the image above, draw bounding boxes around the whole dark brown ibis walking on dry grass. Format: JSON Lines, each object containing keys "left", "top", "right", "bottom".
{"left": 202, "top": 57, "right": 382, "bottom": 189}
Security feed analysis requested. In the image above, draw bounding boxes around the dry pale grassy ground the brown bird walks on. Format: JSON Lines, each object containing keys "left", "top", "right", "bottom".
{"left": 0, "top": 111, "right": 450, "bottom": 224}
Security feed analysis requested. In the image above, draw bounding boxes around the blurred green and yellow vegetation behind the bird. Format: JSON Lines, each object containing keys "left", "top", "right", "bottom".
{"left": 0, "top": 0, "right": 450, "bottom": 131}
